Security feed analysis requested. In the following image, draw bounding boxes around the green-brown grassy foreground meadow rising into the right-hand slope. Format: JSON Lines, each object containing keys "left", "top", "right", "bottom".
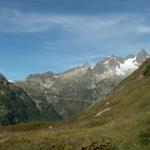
{"left": 0, "top": 59, "right": 150, "bottom": 150}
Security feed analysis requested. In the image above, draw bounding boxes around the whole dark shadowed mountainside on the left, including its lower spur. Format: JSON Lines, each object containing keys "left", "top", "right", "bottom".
{"left": 0, "top": 74, "right": 61, "bottom": 125}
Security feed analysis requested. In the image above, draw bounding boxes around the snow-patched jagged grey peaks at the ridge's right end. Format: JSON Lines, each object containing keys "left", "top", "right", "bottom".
{"left": 93, "top": 49, "right": 149, "bottom": 78}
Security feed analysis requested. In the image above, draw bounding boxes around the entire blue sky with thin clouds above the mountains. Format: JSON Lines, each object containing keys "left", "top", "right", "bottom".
{"left": 0, "top": 0, "right": 150, "bottom": 80}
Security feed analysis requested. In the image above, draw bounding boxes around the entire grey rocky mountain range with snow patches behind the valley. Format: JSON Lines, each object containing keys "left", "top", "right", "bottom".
{"left": 15, "top": 50, "right": 149, "bottom": 118}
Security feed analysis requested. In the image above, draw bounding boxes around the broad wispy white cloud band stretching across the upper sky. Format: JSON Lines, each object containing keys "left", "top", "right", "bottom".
{"left": 0, "top": 8, "right": 150, "bottom": 43}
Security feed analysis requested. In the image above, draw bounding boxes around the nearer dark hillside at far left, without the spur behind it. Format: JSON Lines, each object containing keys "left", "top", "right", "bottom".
{"left": 0, "top": 74, "right": 39, "bottom": 125}
